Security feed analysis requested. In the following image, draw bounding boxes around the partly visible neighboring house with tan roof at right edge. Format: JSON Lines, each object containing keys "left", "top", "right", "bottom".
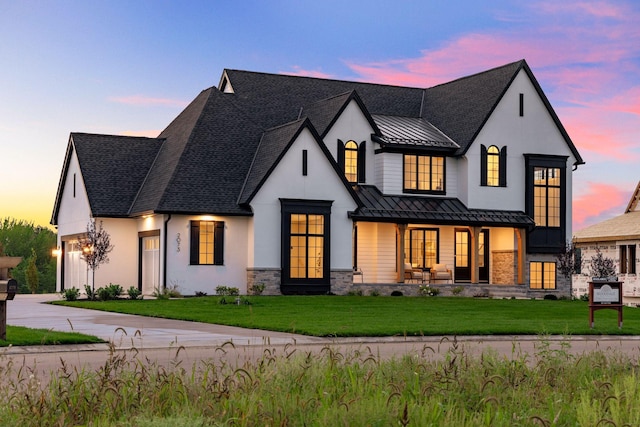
{"left": 572, "top": 182, "right": 640, "bottom": 305}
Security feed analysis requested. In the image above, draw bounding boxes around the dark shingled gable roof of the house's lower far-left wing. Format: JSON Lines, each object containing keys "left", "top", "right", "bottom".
{"left": 52, "top": 133, "right": 164, "bottom": 224}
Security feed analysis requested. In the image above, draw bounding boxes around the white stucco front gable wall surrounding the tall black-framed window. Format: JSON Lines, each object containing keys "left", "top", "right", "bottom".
{"left": 248, "top": 130, "right": 356, "bottom": 269}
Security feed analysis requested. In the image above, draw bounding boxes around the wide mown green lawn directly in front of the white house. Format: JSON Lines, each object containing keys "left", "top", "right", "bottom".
{"left": 56, "top": 296, "right": 640, "bottom": 337}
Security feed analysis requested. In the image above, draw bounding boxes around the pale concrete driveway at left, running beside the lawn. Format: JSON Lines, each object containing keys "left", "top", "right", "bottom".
{"left": 7, "top": 294, "right": 324, "bottom": 349}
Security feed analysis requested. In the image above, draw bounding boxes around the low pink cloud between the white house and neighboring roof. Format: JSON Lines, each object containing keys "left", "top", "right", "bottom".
{"left": 573, "top": 182, "right": 635, "bottom": 231}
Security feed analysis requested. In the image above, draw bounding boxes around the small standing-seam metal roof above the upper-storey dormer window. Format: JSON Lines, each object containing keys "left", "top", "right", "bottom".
{"left": 373, "top": 115, "right": 460, "bottom": 149}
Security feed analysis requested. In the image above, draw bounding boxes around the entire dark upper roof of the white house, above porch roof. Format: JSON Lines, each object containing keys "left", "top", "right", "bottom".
{"left": 52, "top": 61, "right": 582, "bottom": 224}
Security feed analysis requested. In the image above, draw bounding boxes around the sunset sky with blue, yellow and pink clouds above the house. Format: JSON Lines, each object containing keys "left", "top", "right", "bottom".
{"left": 0, "top": 0, "right": 640, "bottom": 231}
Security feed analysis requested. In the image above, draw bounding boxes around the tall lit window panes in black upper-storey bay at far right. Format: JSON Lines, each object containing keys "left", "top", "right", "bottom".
{"left": 533, "top": 167, "right": 560, "bottom": 227}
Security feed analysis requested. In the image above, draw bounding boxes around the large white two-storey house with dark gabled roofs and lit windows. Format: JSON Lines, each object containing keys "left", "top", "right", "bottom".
{"left": 52, "top": 60, "right": 584, "bottom": 297}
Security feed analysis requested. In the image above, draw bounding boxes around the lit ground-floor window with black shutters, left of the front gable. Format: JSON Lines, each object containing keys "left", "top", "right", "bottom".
{"left": 190, "top": 221, "right": 224, "bottom": 265}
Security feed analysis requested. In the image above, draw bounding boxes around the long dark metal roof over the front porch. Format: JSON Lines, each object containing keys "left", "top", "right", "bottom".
{"left": 349, "top": 185, "right": 535, "bottom": 229}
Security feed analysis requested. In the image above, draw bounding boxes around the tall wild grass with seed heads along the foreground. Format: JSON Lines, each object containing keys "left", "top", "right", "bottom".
{"left": 0, "top": 339, "right": 640, "bottom": 426}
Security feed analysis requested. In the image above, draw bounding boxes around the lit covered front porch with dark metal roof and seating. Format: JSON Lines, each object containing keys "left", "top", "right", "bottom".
{"left": 350, "top": 186, "right": 534, "bottom": 297}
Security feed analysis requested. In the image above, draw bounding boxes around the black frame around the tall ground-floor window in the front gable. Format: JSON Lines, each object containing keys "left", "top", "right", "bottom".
{"left": 280, "top": 199, "right": 333, "bottom": 295}
